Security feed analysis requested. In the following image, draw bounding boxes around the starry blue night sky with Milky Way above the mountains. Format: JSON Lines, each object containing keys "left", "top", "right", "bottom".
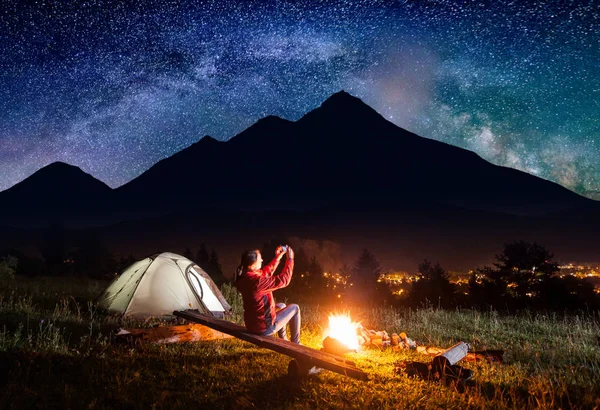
{"left": 0, "top": 0, "right": 600, "bottom": 199}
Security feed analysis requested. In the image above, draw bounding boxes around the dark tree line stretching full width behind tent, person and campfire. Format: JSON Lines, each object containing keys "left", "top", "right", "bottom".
{"left": 0, "top": 227, "right": 600, "bottom": 311}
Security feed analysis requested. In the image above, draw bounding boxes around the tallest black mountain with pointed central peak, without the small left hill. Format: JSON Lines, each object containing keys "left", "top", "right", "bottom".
{"left": 116, "top": 91, "right": 593, "bottom": 214}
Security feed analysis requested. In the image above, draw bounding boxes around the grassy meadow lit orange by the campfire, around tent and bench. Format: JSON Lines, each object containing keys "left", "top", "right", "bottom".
{"left": 0, "top": 277, "right": 600, "bottom": 409}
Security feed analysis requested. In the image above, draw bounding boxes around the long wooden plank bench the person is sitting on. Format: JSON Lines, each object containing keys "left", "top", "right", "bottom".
{"left": 173, "top": 310, "right": 367, "bottom": 380}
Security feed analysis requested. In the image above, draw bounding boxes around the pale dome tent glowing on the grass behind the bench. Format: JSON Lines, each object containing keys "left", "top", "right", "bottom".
{"left": 98, "top": 252, "right": 231, "bottom": 319}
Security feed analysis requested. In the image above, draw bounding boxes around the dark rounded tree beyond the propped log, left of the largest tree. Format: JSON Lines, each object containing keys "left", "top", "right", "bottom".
{"left": 408, "top": 260, "right": 456, "bottom": 309}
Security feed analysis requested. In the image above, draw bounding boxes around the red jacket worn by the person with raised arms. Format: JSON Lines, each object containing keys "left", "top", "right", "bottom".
{"left": 235, "top": 257, "right": 294, "bottom": 334}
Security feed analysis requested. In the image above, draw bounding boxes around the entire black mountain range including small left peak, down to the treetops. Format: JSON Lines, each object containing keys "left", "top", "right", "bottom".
{"left": 0, "top": 91, "right": 600, "bottom": 267}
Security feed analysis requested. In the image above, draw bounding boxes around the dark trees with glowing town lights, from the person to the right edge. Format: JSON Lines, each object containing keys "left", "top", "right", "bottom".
{"left": 265, "top": 241, "right": 600, "bottom": 311}
